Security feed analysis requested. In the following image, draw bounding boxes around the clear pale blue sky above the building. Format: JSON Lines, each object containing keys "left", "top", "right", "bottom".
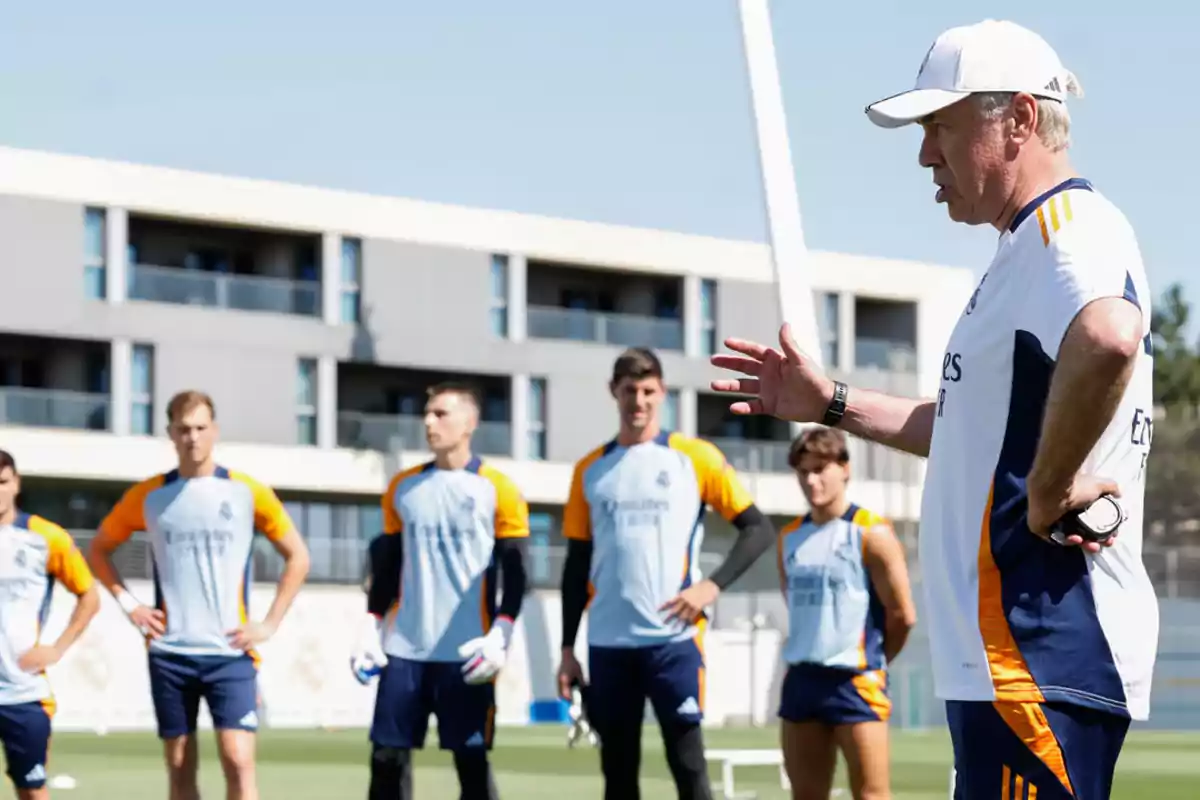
{"left": 0, "top": 0, "right": 1200, "bottom": 316}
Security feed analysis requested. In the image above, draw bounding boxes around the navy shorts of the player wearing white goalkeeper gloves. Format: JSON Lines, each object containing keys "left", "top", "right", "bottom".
{"left": 371, "top": 656, "right": 496, "bottom": 751}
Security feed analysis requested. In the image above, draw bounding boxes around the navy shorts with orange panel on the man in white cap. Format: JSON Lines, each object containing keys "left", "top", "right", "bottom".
{"left": 946, "top": 700, "right": 1129, "bottom": 800}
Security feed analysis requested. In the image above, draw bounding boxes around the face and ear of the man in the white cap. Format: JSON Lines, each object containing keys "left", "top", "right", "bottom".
{"left": 918, "top": 94, "right": 1037, "bottom": 225}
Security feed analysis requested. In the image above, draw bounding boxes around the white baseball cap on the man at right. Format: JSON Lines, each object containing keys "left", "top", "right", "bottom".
{"left": 866, "top": 19, "right": 1084, "bottom": 128}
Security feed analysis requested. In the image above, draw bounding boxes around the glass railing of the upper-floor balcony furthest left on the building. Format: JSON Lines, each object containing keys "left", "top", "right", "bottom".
{"left": 128, "top": 264, "right": 320, "bottom": 317}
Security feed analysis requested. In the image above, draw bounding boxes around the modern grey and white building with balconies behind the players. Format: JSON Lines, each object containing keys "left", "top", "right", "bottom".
{"left": 0, "top": 148, "right": 974, "bottom": 581}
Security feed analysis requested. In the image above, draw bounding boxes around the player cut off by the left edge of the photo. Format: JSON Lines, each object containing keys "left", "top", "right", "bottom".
{"left": 0, "top": 450, "right": 100, "bottom": 800}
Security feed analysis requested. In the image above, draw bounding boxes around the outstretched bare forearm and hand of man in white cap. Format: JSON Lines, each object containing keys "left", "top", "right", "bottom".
{"left": 712, "top": 323, "right": 936, "bottom": 457}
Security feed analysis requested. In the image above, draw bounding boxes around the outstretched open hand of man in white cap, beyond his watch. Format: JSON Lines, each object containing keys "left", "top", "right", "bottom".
{"left": 712, "top": 323, "right": 833, "bottom": 422}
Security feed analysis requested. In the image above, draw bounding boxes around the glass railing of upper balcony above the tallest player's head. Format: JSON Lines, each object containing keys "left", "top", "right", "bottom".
{"left": 526, "top": 306, "right": 683, "bottom": 350}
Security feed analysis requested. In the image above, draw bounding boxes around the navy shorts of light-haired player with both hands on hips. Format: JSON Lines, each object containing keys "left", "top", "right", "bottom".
{"left": 150, "top": 652, "right": 258, "bottom": 739}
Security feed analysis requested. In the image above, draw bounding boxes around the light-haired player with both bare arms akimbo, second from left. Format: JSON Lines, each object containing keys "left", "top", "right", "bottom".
{"left": 89, "top": 391, "right": 308, "bottom": 800}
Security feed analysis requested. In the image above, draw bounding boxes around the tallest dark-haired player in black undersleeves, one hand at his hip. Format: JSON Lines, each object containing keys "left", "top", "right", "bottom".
{"left": 558, "top": 348, "right": 775, "bottom": 800}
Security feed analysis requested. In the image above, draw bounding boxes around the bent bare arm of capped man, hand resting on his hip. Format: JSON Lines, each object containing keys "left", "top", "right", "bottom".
{"left": 1026, "top": 297, "right": 1142, "bottom": 552}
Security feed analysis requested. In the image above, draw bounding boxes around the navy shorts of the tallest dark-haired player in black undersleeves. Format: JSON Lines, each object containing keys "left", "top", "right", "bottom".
{"left": 588, "top": 639, "right": 704, "bottom": 739}
